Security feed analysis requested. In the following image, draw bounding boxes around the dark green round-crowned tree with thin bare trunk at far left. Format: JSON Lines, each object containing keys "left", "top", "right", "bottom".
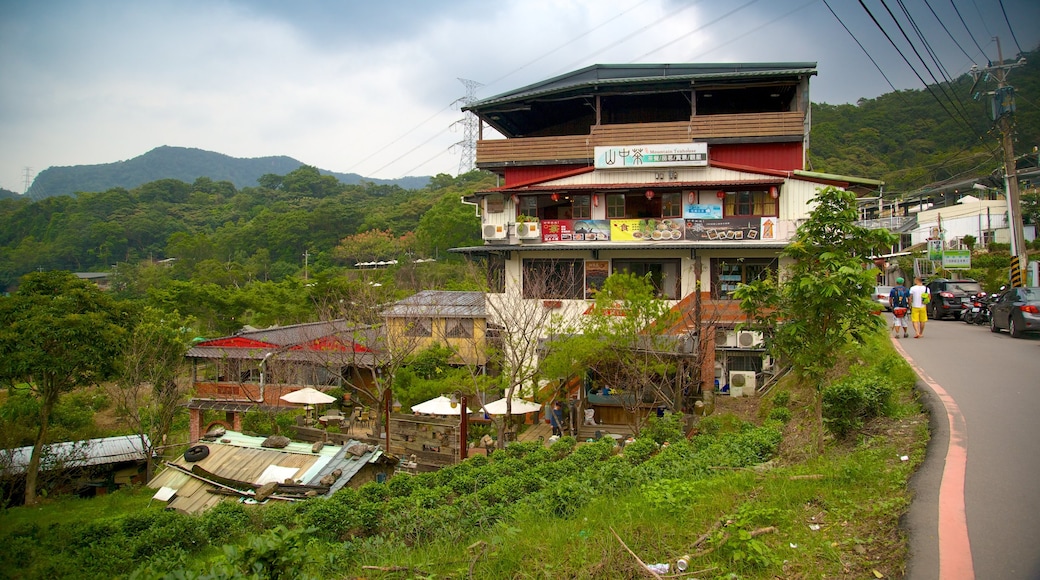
{"left": 0, "top": 271, "right": 130, "bottom": 505}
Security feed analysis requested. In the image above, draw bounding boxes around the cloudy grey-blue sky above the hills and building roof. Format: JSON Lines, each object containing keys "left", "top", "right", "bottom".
{"left": 0, "top": 0, "right": 1040, "bottom": 192}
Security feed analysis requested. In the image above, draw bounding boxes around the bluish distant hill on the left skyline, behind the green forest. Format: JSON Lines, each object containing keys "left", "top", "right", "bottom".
{"left": 29, "top": 146, "right": 430, "bottom": 200}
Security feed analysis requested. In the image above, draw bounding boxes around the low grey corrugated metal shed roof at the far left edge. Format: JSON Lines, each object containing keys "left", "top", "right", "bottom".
{"left": 2, "top": 436, "right": 151, "bottom": 476}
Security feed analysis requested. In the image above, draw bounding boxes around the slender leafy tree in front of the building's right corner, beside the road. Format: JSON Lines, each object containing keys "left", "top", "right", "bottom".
{"left": 734, "top": 187, "right": 893, "bottom": 453}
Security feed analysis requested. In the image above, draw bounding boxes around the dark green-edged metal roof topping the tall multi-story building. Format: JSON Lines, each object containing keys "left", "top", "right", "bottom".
{"left": 463, "top": 62, "right": 816, "bottom": 113}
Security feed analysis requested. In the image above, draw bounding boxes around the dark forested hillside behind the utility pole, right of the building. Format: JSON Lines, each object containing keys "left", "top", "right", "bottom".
{"left": 809, "top": 51, "right": 1040, "bottom": 191}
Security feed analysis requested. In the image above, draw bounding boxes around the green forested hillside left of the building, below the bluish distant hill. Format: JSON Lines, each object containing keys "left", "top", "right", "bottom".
{"left": 0, "top": 166, "right": 494, "bottom": 329}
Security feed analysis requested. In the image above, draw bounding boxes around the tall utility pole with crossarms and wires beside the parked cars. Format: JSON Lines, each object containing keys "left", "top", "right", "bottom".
{"left": 970, "top": 36, "right": 1026, "bottom": 287}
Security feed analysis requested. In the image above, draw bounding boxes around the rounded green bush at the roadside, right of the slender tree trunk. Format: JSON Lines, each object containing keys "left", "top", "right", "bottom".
{"left": 824, "top": 372, "right": 894, "bottom": 439}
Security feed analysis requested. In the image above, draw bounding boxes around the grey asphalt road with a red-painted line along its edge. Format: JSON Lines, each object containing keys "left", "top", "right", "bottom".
{"left": 895, "top": 320, "right": 1040, "bottom": 580}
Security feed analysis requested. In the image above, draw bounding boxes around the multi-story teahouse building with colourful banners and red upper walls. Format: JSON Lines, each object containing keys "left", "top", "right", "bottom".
{"left": 454, "top": 62, "right": 881, "bottom": 417}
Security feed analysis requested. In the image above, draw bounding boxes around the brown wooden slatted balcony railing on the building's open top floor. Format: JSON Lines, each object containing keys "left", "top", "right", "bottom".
{"left": 476, "top": 111, "right": 805, "bottom": 166}
